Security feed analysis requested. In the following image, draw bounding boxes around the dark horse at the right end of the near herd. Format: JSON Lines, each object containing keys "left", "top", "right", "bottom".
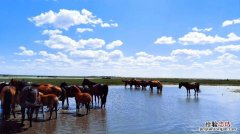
{"left": 82, "top": 79, "right": 108, "bottom": 108}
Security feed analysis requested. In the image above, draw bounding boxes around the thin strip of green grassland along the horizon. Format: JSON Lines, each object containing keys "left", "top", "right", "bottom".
{"left": 0, "top": 75, "right": 240, "bottom": 86}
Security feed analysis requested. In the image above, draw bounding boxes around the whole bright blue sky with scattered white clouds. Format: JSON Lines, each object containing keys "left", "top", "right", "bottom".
{"left": 0, "top": 0, "right": 240, "bottom": 79}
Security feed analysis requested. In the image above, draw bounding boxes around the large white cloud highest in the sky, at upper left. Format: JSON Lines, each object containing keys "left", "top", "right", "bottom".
{"left": 28, "top": 9, "right": 118, "bottom": 30}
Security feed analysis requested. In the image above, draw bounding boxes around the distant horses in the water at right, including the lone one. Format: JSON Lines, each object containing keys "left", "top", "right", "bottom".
{"left": 122, "top": 79, "right": 200, "bottom": 96}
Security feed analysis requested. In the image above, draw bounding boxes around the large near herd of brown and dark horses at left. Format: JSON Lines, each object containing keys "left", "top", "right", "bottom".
{"left": 0, "top": 79, "right": 108, "bottom": 127}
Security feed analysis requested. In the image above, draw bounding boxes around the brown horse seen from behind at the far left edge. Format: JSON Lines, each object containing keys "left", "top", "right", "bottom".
{"left": 1, "top": 86, "right": 17, "bottom": 119}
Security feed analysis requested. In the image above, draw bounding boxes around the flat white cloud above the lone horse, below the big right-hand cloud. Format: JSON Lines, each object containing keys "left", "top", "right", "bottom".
{"left": 171, "top": 49, "right": 212, "bottom": 58}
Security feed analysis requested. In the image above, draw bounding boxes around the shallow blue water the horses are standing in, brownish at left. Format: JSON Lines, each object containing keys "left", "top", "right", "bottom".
{"left": 0, "top": 86, "right": 240, "bottom": 134}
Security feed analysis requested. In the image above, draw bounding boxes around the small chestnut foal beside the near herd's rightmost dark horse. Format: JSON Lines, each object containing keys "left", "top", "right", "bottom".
{"left": 72, "top": 85, "right": 92, "bottom": 114}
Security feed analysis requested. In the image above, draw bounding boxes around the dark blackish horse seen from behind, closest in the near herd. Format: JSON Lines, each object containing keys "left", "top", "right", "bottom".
{"left": 19, "top": 86, "right": 41, "bottom": 127}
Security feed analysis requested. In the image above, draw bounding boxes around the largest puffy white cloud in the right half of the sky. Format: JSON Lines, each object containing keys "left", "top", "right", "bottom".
{"left": 179, "top": 32, "right": 240, "bottom": 45}
